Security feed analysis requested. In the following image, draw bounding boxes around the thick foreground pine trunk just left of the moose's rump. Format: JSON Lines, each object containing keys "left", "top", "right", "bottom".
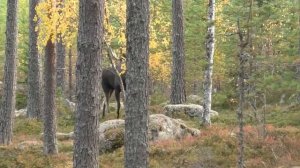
{"left": 73, "top": 0, "right": 104, "bottom": 168}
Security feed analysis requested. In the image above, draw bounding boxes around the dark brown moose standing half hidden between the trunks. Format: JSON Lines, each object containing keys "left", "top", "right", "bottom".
{"left": 101, "top": 68, "right": 126, "bottom": 118}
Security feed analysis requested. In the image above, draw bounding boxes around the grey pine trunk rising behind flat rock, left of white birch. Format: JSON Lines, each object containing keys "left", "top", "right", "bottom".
{"left": 170, "top": 0, "right": 186, "bottom": 104}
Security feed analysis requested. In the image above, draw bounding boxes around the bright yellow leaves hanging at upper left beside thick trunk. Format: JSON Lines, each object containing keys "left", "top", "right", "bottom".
{"left": 35, "top": 0, "right": 78, "bottom": 52}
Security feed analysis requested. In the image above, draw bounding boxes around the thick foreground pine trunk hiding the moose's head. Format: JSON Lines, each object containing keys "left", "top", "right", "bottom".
{"left": 125, "top": 0, "right": 149, "bottom": 168}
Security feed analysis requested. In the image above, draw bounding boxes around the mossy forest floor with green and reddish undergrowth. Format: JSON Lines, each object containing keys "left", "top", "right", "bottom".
{"left": 0, "top": 98, "right": 300, "bottom": 168}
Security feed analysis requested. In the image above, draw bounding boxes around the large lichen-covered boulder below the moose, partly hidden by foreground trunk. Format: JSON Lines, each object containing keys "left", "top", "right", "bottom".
{"left": 99, "top": 114, "right": 200, "bottom": 153}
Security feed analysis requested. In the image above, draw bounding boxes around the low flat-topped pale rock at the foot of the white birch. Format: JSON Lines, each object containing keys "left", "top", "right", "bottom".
{"left": 164, "top": 104, "right": 218, "bottom": 118}
